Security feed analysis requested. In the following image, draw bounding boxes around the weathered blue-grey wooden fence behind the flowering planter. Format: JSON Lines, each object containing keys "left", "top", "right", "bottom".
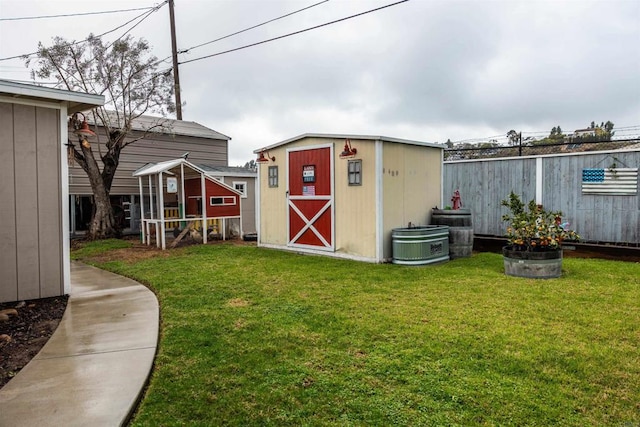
{"left": 443, "top": 147, "right": 640, "bottom": 246}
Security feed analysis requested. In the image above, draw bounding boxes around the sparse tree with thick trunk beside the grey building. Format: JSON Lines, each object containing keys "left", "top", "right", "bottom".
{"left": 25, "top": 35, "right": 175, "bottom": 239}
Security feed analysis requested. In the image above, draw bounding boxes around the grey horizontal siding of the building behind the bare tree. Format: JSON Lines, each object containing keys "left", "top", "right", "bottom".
{"left": 69, "top": 130, "right": 228, "bottom": 196}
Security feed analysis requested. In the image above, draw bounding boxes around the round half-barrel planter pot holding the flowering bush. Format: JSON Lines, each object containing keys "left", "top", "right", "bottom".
{"left": 502, "top": 246, "right": 562, "bottom": 279}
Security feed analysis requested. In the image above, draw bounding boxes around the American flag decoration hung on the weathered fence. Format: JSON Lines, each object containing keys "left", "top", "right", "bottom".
{"left": 582, "top": 168, "right": 638, "bottom": 195}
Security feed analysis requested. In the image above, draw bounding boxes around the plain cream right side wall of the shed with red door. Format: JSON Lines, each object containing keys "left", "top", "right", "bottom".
{"left": 382, "top": 142, "right": 442, "bottom": 258}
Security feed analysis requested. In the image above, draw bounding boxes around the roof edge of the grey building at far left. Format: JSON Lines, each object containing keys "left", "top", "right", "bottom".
{"left": 0, "top": 80, "right": 104, "bottom": 114}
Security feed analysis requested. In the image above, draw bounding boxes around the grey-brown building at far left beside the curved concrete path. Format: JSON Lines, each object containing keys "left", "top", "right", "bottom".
{"left": 0, "top": 80, "right": 104, "bottom": 302}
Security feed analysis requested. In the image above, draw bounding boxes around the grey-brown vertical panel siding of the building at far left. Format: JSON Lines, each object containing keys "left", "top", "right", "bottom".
{"left": 0, "top": 102, "right": 64, "bottom": 301}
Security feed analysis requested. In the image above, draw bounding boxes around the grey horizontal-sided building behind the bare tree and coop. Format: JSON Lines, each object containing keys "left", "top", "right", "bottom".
{"left": 69, "top": 114, "right": 231, "bottom": 234}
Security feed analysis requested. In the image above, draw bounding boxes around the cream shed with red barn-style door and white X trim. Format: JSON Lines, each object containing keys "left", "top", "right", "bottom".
{"left": 255, "top": 134, "right": 444, "bottom": 262}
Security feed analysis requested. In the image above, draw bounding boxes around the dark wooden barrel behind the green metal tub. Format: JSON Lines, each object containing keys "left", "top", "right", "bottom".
{"left": 431, "top": 209, "right": 473, "bottom": 259}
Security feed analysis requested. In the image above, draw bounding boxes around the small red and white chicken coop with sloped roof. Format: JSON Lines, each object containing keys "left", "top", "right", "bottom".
{"left": 133, "top": 158, "right": 243, "bottom": 249}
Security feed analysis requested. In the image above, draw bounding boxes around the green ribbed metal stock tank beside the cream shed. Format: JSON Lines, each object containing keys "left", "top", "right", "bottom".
{"left": 391, "top": 225, "right": 449, "bottom": 265}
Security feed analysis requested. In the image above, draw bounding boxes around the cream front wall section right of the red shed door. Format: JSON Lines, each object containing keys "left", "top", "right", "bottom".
{"left": 334, "top": 140, "right": 376, "bottom": 258}
